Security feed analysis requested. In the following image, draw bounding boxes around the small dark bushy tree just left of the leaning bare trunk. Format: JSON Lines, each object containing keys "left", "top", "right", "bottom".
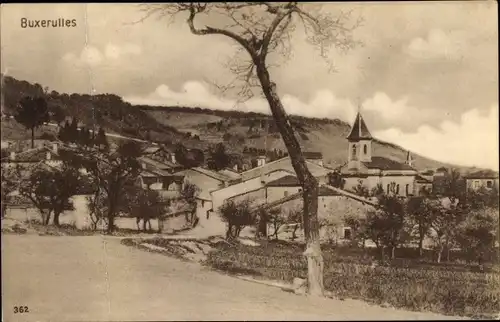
{"left": 218, "top": 199, "right": 257, "bottom": 239}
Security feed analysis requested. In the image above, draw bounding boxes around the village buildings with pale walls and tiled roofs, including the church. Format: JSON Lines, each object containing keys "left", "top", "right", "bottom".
{"left": 1, "top": 113, "right": 499, "bottom": 238}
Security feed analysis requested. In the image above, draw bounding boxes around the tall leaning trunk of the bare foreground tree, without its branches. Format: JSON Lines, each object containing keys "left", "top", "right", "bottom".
{"left": 254, "top": 59, "right": 323, "bottom": 296}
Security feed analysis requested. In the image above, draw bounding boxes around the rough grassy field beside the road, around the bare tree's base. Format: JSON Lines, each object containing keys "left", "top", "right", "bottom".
{"left": 207, "top": 242, "right": 500, "bottom": 318}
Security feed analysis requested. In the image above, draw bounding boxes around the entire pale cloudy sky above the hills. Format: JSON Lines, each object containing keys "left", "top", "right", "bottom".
{"left": 1, "top": 1, "right": 499, "bottom": 170}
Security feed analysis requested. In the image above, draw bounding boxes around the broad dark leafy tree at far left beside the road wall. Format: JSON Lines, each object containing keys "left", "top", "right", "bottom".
{"left": 19, "top": 165, "right": 79, "bottom": 226}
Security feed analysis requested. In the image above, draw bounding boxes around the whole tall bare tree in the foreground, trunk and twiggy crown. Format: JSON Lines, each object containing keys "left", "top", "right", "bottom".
{"left": 141, "top": 2, "right": 360, "bottom": 295}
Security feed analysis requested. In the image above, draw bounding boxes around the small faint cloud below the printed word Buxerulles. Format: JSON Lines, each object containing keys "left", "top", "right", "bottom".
{"left": 63, "top": 43, "right": 142, "bottom": 67}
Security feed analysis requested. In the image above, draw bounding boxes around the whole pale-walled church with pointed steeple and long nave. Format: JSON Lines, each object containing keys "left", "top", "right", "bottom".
{"left": 340, "top": 112, "right": 420, "bottom": 197}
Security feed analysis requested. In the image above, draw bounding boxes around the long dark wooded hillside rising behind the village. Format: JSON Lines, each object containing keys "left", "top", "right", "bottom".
{"left": 2, "top": 76, "right": 465, "bottom": 170}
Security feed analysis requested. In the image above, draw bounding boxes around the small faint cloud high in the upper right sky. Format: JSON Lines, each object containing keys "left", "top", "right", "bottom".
{"left": 405, "top": 29, "right": 465, "bottom": 59}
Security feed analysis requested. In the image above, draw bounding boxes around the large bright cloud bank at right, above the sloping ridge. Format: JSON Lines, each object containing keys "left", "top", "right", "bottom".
{"left": 373, "top": 105, "right": 498, "bottom": 170}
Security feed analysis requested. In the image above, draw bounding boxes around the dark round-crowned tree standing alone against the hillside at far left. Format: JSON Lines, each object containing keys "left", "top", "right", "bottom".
{"left": 14, "top": 96, "right": 49, "bottom": 148}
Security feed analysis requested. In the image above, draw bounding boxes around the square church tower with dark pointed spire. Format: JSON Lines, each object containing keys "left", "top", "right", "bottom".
{"left": 347, "top": 112, "right": 373, "bottom": 169}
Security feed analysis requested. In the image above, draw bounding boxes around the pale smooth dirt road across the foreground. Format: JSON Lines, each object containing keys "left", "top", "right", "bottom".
{"left": 2, "top": 235, "right": 464, "bottom": 322}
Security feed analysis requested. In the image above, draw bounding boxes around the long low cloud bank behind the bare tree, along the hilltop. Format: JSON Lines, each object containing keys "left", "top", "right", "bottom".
{"left": 124, "top": 81, "right": 356, "bottom": 122}
